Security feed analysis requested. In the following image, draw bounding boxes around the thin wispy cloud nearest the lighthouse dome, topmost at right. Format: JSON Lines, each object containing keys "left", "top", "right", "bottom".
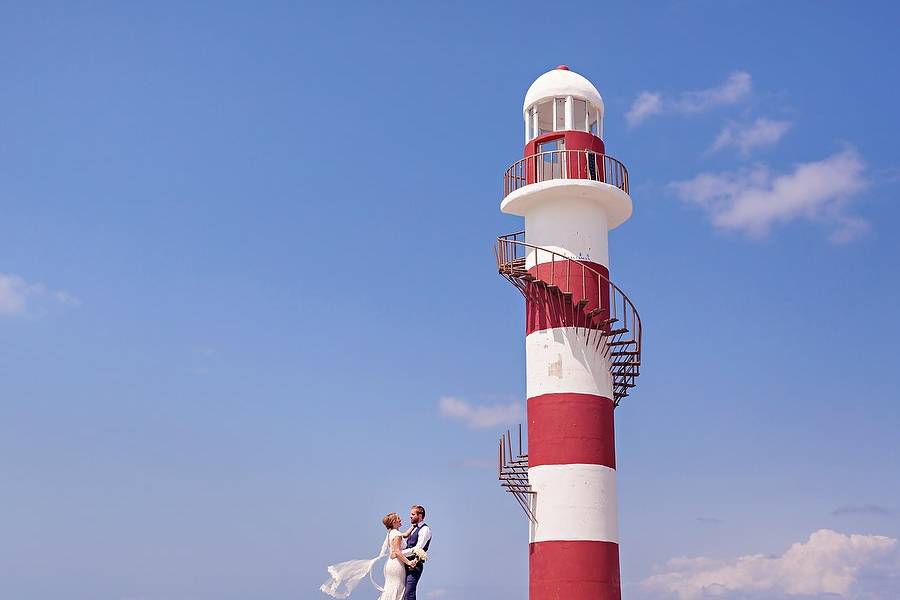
{"left": 625, "top": 71, "right": 753, "bottom": 127}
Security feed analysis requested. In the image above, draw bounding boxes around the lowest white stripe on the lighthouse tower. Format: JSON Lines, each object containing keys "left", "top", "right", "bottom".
{"left": 528, "top": 465, "right": 619, "bottom": 544}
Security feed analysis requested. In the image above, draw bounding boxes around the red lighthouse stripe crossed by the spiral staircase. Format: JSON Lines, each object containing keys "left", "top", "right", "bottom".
{"left": 525, "top": 260, "right": 609, "bottom": 334}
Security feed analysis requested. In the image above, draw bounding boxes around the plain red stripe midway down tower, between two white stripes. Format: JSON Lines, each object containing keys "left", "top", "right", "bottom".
{"left": 528, "top": 393, "right": 616, "bottom": 469}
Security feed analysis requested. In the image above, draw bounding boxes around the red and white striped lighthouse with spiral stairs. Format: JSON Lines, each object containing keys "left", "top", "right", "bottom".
{"left": 495, "top": 65, "right": 641, "bottom": 600}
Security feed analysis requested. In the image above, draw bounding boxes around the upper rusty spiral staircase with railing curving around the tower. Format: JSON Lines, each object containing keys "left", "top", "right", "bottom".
{"left": 495, "top": 231, "right": 641, "bottom": 406}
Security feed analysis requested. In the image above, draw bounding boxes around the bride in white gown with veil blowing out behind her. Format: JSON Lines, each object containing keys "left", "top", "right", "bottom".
{"left": 319, "top": 513, "right": 418, "bottom": 600}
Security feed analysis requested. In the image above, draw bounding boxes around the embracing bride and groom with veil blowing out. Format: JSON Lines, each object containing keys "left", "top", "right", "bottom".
{"left": 319, "top": 504, "right": 431, "bottom": 600}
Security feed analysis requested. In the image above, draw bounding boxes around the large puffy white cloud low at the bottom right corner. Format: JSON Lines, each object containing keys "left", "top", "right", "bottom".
{"left": 642, "top": 529, "right": 900, "bottom": 600}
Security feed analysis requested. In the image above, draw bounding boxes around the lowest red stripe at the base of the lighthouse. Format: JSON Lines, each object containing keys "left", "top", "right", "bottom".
{"left": 528, "top": 542, "right": 622, "bottom": 600}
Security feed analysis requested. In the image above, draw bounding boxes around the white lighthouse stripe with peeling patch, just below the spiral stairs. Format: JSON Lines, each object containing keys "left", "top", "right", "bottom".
{"left": 525, "top": 327, "right": 612, "bottom": 398}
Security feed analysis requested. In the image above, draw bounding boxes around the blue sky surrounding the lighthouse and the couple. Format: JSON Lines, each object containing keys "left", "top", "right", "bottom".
{"left": 0, "top": 2, "right": 900, "bottom": 600}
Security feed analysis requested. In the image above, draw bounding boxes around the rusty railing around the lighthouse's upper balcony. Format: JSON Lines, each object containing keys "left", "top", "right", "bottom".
{"left": 503, "top": 150, "right": 629, "bottom": 198}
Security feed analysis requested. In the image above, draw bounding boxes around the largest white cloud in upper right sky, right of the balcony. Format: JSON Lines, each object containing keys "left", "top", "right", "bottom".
{"left": 669, "top": 148, "right": 869, "bottom": 243}
